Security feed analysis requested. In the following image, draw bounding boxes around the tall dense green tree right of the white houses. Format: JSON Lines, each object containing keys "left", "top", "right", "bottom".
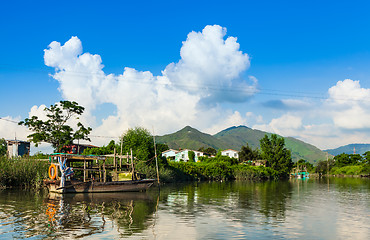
{"left": 260, "top": 134, "right": 293, "bottom": 178}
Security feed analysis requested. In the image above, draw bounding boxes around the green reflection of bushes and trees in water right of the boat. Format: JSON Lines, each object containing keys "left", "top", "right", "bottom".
{"left": 160, "top": 181, "right": 293, "bottom": 222}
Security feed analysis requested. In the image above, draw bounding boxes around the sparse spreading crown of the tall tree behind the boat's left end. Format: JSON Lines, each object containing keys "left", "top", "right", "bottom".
{"left": 19, "top": 101, "right": 92, "bottom": 151}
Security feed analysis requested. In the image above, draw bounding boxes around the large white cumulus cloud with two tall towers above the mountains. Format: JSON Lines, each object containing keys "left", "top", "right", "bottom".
{"left": 44, "top": 25, "right": 257, "bottom": 143}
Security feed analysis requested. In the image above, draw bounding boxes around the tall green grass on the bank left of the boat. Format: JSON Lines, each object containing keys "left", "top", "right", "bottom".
{"left": 0, "top": 157, "right": 49, "bottom": 189}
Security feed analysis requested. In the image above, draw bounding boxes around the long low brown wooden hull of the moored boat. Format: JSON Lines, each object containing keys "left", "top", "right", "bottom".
{"left": 44, "top": 179, "right": 155, "bottom": 193}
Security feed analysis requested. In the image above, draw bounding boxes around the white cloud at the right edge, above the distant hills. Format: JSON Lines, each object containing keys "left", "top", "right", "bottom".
{"left": 253, "top": 79, "right": 370, "bottom": 149}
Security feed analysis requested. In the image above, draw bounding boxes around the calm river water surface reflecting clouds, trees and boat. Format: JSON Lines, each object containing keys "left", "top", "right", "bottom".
{"left": 0, "top": 178, "right": 370, "bottom": 239}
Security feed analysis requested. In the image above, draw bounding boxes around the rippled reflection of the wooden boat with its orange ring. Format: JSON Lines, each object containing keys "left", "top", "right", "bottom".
{"left": 45, "top": 192, "right": 157, "bottom": 238}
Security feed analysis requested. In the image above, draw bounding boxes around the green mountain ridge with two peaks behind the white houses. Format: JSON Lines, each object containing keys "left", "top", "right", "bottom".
{"left": 156, "top": 126, "right": 326, "bottom": 163}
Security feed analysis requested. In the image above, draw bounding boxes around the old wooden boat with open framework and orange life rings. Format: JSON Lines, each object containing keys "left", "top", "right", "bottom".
{"left": 44, "top": 153, "right": 155, "bottom": 194}
